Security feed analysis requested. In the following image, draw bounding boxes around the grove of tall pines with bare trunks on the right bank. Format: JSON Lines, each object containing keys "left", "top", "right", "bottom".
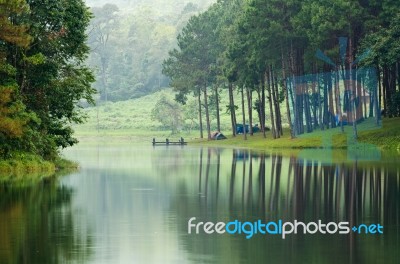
{"left": 163, "top": 0, "right": 400, "bottom": 138}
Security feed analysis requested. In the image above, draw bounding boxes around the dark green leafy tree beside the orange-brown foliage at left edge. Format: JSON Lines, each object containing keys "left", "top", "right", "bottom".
{"left": 20, "top": 0, "right": 95, "bottom": 155}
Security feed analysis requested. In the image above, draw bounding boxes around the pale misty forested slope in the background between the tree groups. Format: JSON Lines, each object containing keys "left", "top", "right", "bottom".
{"left": 86, "top": 0, "right": 215, "bottom": 101}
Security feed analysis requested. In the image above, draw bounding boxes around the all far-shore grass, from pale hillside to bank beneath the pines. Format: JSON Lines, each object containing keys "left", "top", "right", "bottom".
{"left": 75, "top": 89, "right": 400, "bottom": 152}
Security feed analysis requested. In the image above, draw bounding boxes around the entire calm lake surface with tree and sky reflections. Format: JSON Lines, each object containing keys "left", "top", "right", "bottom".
{"left": 0, "top": 143, "right": 400, "bottom": 264}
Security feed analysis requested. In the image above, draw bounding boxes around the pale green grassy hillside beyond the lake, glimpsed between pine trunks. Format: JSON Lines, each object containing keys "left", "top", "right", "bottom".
{"left": 74, "top": 89, "right": 266, "bottom": 138}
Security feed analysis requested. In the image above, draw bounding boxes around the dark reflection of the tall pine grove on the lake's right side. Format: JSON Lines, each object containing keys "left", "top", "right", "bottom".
{"left": 172, "top": 149, "right": 400, "bottom": 263}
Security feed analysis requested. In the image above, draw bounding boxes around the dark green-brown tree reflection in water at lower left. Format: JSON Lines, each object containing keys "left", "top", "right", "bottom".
{"left": 0, "top": 180, "right": 92, "bottom": 263}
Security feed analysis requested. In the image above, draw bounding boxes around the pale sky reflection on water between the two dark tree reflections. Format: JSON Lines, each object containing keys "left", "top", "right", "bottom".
{"left": 63, "top": 147, "right": 194, "bottom": 263}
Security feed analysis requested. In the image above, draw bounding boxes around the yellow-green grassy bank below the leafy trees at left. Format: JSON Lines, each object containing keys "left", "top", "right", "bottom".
{"left": 0, "top": 153, "right": 78, "bottom": 182}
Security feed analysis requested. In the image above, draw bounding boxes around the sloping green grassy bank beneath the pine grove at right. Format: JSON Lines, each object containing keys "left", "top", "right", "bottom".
{"left": 190, "top": 118, "right": 400, "bottom": 150}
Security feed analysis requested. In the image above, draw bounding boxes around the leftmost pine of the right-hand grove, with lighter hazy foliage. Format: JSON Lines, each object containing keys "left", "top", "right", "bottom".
{"left": 163, "top": 0, "right": 227, "bottom": 137}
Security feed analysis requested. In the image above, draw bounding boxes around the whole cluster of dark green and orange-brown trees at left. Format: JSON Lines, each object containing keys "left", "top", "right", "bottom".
{"left": 0, "top": 0, "right": 95, "bottom": 160}
